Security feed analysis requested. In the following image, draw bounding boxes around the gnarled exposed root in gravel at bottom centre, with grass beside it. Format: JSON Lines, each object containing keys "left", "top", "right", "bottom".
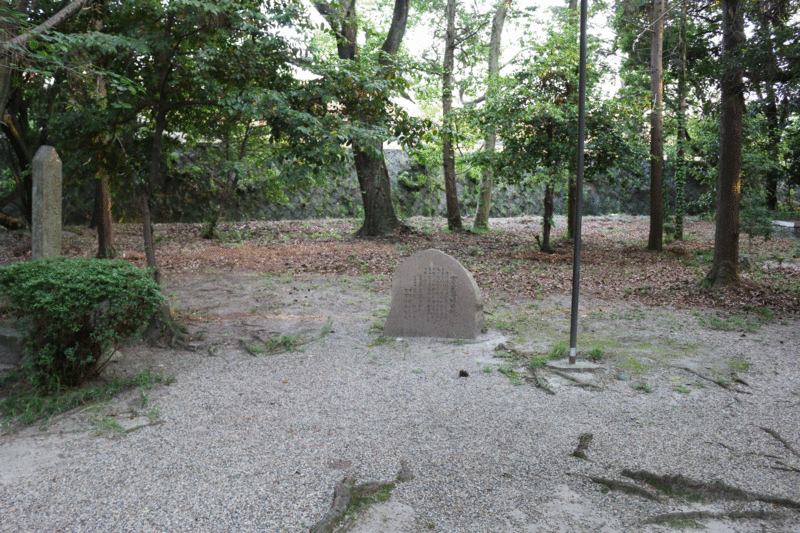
{"left": 309, "top": 461, "right": 414, "bottom": 533}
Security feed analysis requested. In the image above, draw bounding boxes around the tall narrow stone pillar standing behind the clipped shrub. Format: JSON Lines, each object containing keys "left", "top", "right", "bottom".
{"left": 31, "top": 146, "right": 61, "bottom": 259}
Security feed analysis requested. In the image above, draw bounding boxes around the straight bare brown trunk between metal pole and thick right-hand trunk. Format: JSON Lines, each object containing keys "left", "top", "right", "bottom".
{"left": 647, "top": 0, "right": 664, "bottom": 251}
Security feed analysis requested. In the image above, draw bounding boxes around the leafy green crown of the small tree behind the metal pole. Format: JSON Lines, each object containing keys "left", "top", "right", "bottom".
{"left": 474, "top": 11, "right": 646, "bottom": 192}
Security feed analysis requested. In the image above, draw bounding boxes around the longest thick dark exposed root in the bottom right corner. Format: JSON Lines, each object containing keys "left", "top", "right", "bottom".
{"left": 622, "top": 469, "right": 800, "bottom": 509}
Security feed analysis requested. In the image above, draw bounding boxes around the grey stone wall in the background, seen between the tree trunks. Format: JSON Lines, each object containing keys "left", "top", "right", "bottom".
{"left": 147, "top": 150, "right": 704, "bottom": 222}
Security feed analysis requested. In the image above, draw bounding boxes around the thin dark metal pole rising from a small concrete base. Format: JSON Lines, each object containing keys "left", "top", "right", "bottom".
{"left": 569, "top": 0, "right": 588, "bottom": 365}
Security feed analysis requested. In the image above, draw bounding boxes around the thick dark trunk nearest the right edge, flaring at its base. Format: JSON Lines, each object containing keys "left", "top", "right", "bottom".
{"left": 706, "top": 0, "right": 745, "bottom": 287}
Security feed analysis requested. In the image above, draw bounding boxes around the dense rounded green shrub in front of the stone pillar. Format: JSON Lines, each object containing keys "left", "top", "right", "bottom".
{"left": 0, "top": 257, "right": 163, "bottom": 391}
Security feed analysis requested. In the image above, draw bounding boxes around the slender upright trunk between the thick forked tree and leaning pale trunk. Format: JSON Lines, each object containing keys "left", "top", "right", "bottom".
{"left": 442, "top": 0, "right": 464, "bottom": 231}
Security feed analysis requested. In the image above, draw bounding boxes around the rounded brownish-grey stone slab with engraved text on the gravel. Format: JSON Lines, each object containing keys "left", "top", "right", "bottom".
{"left": 383, "top": 250, "right": 483, "bottom": 339}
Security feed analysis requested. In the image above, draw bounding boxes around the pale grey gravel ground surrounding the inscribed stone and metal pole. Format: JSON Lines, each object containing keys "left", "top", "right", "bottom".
{"left": 0, "top": 274, "right": 800, "bottom": 533}
